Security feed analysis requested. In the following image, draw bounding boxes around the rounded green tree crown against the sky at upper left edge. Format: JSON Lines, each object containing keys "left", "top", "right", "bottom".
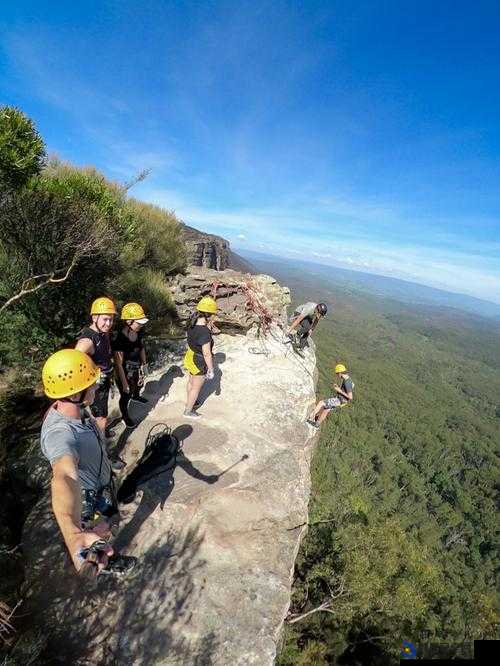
{"left": 0, "top": 106, "right": 45, "bottom": 190}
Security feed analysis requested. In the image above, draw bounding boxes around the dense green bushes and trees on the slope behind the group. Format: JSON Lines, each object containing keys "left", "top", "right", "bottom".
{"left": 0, "top": 108, "right": 186, "bottom": 380}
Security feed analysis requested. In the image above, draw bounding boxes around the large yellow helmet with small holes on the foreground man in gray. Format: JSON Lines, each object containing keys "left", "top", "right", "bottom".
{"left": 42, "top": 349, "right": 101, "bottom": 399}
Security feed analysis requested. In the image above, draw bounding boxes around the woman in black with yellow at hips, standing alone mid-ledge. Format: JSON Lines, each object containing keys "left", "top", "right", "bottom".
{"left": 184, "top": 296, "right": 217, "bottom": 418}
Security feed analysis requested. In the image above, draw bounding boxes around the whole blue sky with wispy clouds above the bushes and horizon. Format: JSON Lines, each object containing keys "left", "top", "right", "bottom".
{"left": 0, "top": 0, "right": 500, "bottom": 302}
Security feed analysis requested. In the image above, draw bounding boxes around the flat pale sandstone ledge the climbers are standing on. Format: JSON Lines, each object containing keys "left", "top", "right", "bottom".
{"left": 24, "top": 294, "right": 315, "bottom": 666}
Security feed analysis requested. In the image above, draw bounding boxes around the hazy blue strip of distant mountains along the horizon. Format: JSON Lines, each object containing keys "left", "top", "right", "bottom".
{"left": 238, "top": 248, "right": 500, "bottom": 322}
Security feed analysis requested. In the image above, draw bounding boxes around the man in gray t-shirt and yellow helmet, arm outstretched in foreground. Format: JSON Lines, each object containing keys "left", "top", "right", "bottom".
{"left": 40, "top": 349, "right": 137, "bottom": 576}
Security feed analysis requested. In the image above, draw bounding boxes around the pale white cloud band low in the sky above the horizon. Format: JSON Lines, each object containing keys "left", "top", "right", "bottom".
{"left": 139, "top": 185, "right": 500, "bottom": 302}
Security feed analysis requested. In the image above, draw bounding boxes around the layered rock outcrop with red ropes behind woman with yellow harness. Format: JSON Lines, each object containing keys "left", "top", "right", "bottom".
{"left": 170, "top": 267, "right": 290, "bottom": 332}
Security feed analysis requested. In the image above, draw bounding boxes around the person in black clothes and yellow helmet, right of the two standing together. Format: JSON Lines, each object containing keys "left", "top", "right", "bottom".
{"left": 112, "top": 303, "right": 149, "bottom": 428}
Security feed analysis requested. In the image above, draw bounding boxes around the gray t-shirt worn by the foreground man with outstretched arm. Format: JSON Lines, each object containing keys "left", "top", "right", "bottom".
{"left": 40, "top": 408, "right": 111, "bottom": 491}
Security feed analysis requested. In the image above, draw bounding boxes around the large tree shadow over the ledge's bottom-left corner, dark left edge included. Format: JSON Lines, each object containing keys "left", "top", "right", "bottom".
{"left": 25, "top": 502, "right": 217, "bottom": 666}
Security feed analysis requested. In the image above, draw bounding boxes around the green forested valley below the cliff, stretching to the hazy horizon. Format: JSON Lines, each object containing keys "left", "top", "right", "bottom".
{"left": 252, "top": 259, "right": 500, "bottom": 666}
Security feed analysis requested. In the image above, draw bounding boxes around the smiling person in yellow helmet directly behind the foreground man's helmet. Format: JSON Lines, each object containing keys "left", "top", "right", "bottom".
{"left": 75, "top": 296, "right": 116, "bottom": 437}
